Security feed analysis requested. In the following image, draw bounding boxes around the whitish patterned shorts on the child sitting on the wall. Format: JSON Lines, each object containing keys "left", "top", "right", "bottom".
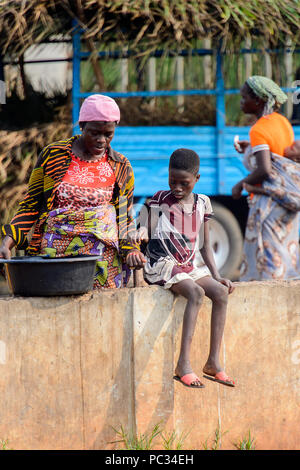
{"left": 144, "top": 256, "right": 211, "bottom": 289}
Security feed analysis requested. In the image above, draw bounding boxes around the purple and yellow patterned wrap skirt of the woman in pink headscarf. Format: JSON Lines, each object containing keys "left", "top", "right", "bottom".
{"left": 41, "top": 204, "right": 130, "bottom": 290}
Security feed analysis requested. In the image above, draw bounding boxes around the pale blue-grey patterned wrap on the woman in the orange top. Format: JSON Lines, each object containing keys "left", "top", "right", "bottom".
{"left": 240, "top": 154, "right": 300, "bottom": 281}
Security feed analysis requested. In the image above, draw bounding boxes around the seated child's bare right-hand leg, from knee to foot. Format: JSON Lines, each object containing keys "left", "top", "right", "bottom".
{"left": 196, "top": 276, "right": 228, "bottom": 375}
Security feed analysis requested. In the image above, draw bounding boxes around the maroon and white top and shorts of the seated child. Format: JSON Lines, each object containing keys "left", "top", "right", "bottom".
{"left": 144, "top": 191, "right": 212, "bottom": 289}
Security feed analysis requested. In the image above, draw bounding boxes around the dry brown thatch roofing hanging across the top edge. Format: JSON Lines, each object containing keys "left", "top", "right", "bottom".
{"left": 0, "top": 0, "right": 300, "bottom": 54}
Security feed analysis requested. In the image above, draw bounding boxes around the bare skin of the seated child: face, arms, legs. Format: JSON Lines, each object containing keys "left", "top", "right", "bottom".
{"left": 132, "top": 168, "right": 234, "bottom": 388}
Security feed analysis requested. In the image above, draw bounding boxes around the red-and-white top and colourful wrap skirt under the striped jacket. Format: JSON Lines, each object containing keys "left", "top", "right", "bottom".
{"left": 41, "top": 154, "right": 126, "bottom": 289}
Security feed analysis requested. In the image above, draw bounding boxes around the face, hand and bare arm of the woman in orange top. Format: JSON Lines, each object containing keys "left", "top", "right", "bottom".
{"left": 232, "top": 83, "right": 271, "bottom": 199}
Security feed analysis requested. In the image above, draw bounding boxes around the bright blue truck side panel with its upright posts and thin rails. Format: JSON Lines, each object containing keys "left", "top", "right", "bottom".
{"left": 72, "top": 30, "right": 300, "bottom": 201}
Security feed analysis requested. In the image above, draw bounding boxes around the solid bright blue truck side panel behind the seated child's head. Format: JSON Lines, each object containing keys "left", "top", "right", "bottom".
{"left": 113, "top": 126, "right": 249, "bottom": 197}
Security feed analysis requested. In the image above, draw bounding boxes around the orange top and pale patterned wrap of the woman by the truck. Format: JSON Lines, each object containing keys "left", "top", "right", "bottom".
{"left": 240, "top": 113, "right": 300, "bottom": 281}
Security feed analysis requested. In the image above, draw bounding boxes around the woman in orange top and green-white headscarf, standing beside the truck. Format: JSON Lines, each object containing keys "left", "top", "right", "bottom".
{"left": 232, "top": 76, "right": 300, "bottom": 281}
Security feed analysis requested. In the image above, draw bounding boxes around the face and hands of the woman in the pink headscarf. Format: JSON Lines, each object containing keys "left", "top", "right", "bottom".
{"left": 0, "top": 121, "right": 146, "bottom": 269}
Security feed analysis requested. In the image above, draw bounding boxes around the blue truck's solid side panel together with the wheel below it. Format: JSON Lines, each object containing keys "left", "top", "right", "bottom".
{"left": 113, "top": 126, "right": 300, "bottom": 279}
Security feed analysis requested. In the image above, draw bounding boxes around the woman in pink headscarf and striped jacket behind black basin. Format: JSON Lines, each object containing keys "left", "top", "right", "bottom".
{"left": 0, "top": 94, "right": 145, "bottom": 289}
